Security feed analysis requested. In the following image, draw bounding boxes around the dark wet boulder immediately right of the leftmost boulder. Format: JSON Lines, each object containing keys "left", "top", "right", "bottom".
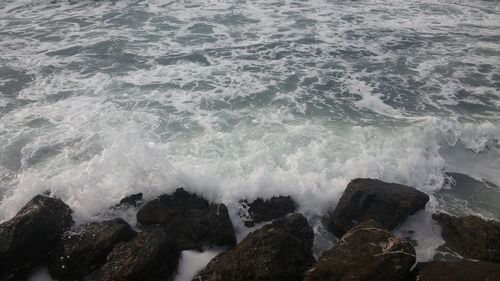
{"left": 49, "top": 219, "right": 136, "bottom": 281}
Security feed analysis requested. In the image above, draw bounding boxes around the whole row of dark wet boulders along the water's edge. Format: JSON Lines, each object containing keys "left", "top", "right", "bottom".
{"left": 0, "top": 179, "right": 500, "bottom": 281}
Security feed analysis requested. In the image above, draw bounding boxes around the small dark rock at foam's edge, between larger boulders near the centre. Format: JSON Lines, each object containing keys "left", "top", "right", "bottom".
{"left": 240, "top": 196, "right": 296, "bottom": 227}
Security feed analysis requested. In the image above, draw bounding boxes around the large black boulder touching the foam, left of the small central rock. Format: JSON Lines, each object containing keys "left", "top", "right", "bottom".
{"left": 137, "top": 188, "right": 236, "bottom": 250}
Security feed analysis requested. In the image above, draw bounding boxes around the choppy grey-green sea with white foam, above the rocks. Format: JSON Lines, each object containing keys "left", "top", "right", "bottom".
{"left": 0, "top": 0, "right": 500, "bottom": 266}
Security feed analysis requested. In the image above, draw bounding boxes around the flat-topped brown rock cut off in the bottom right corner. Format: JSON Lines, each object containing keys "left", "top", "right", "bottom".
{"left": 409, "top": 260, "right": 500, "bottom": 281}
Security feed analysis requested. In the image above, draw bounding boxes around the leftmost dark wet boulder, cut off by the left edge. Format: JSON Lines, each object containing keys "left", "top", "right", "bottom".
{"left": 0, "top": 195, "right": 73, "bottom": 280}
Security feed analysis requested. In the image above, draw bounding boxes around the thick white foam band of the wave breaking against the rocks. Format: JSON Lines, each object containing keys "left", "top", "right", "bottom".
{"left": 1, "top": 111, "right": 492, "bottom": 221}
